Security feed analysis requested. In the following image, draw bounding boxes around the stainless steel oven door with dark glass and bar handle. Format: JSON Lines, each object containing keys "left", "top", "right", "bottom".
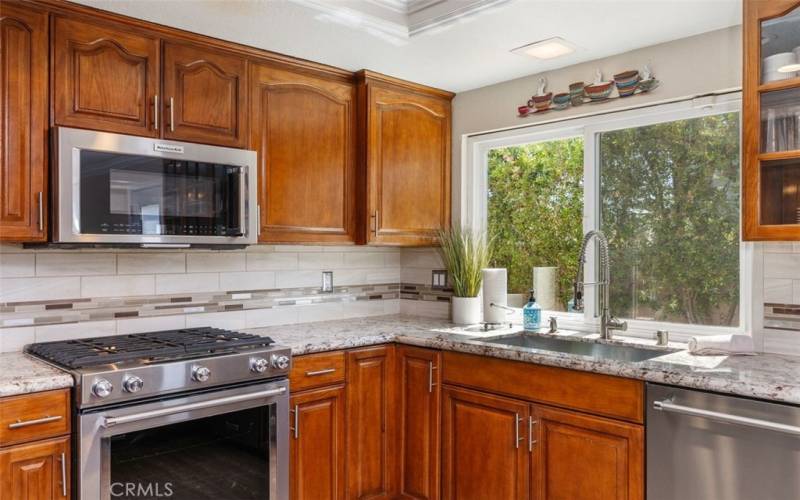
{"left": 77, "top": 380, "right": 289, "bottom": 500}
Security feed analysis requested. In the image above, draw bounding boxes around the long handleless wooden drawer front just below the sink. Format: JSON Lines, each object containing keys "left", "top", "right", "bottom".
{"left": 442, "top": 352, "right": 644, "bottom": 423}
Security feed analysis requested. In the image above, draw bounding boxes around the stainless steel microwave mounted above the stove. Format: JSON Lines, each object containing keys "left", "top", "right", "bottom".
{"left": 52, "top": 127, "right": 258, "bottom": 247}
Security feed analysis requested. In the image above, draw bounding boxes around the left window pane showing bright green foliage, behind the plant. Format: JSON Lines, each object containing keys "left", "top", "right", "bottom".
{"left": 487, "top": 137, "right": 583, "bottom": 311}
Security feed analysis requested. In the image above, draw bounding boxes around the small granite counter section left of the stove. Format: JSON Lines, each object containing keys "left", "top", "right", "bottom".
{"left": 0, "top": 352, "right": 73, "bottom": 397}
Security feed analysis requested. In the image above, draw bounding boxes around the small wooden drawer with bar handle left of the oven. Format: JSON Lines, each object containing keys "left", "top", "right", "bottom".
{"left": 0, "top": 389, "right": 70, "bottom": 446}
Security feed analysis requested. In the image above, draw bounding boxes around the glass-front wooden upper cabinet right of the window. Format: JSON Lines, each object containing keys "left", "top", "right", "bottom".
{"left": 742, "top": 0, "right": 800, "bottom": 240}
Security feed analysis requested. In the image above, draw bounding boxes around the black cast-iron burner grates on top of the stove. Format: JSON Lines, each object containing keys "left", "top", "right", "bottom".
{"left": 27, "top": 328, "right": 274, "bottom": 368}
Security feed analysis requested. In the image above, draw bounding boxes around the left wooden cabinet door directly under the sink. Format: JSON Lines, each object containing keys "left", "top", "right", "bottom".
{"left": 442, "top": 386, "right": 530, "bottom": 500}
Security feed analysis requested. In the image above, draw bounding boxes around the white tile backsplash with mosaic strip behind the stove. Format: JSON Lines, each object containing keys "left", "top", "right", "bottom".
{"left": 0, "top": 245, "right": 450, "bottom": 352}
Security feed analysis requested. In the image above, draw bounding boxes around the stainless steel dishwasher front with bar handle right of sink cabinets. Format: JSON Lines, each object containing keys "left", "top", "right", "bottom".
{"left": 647, "top": 384, "right": 800, "bottom": 500}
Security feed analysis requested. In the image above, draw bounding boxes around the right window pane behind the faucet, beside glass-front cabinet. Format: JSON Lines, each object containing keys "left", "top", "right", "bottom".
{"left": 598, "top": 113, "right": 740, "bottom": 326}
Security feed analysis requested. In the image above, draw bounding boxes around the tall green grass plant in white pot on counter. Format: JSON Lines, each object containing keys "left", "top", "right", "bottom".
{"left": 439, "top": 227, "right": 491, "bottom": 325}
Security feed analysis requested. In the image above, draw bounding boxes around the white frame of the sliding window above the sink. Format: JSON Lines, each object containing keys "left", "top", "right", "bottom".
{"left": 462, "top": 92, "right": 763, "bottom": 341}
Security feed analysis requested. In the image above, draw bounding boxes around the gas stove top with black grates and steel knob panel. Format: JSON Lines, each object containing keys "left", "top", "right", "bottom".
{"left": 25, "top": 327, "right": 291, "bottom": 408}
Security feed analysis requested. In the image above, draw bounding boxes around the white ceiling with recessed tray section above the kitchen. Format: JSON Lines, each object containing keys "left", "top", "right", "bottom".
{"left": 72, "top": 0, "right": 742, "bottom": 92}
